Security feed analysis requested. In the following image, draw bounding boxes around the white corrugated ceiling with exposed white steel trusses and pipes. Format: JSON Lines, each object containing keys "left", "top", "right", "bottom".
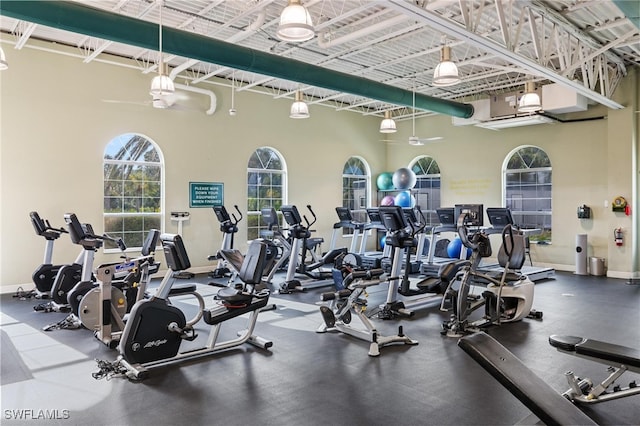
{"left": 0, "top": 0, "right": 640, "bottom": 118}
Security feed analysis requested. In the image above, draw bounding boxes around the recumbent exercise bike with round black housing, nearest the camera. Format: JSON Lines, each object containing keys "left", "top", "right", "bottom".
{"left": 99, "top": 234, "right": 273, "bottom": 380}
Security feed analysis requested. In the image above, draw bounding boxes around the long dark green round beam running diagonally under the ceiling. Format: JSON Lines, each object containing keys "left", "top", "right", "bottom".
{"left": 0, "top": 0, "right": 473, "bottom": 118}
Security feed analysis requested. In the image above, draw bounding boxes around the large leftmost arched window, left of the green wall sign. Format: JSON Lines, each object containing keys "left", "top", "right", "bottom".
{"left": 103, "top": 133, "right": 164, "bottom": 249}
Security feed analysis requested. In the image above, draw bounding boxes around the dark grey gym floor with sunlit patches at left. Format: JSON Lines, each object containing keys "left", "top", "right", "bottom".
{"left": 0, "top": 272, "right": 640, "bottom": 426}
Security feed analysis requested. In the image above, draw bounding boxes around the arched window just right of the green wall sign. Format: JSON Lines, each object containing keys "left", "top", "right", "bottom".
{"left": 247, "top": 147, "right": 287, "bottom": 240}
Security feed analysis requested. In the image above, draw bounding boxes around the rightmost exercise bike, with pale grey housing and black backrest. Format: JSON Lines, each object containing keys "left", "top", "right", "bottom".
{"left": 441, "top": 210, "right": 542, "bottom": 337}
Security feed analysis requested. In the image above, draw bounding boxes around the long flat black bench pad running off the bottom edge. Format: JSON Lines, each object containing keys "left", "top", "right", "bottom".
{"left": 458, "top": 333, "right": 597, "bottom": 425}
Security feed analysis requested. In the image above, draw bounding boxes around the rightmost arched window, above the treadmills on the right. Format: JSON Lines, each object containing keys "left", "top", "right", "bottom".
{"left": 503, "top": 146, "right": 552, "bottom": 242}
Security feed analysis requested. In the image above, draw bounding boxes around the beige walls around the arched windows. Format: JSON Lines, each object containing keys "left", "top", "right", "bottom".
{"left": 0, "top": 43, "right": 638, "bottom": 291}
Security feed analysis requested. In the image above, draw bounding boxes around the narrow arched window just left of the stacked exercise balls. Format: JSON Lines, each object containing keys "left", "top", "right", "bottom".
{"left": 342, "top": 157, "right": 371, "bottom": 234}
